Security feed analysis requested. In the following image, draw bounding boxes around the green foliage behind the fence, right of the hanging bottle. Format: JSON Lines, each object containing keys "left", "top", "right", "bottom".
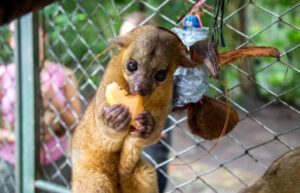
{"left": 211, "top": 0, "right": 300, "bottom": 105}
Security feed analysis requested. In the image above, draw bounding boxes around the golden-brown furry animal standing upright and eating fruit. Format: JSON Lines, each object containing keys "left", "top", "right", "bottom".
{"left": 72, "top": 26, "right": 194, "bottom": 193}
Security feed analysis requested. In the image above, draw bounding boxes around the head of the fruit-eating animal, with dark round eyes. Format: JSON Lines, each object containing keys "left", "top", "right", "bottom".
{"left": 112, "top": 25, "right": 195, "bottom": 96}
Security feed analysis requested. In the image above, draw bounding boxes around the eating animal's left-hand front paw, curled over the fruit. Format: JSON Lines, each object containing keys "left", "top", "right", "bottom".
{"left": 103, "top": 104, "right": 131, "bottom": 131}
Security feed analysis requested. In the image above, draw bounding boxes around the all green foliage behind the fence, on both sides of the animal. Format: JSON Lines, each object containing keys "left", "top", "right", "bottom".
{"left": 0, "top": 0, "right": 300, "bottom": 105}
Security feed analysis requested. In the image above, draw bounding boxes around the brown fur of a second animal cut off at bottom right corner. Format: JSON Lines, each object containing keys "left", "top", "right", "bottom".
{"left": 240, "top": 147, "right": 300, "bottom": 193}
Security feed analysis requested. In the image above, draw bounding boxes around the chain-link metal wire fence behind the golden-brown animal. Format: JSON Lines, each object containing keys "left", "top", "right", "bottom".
{"left": 0, "top": 0, "right": 300, "bottom": 193}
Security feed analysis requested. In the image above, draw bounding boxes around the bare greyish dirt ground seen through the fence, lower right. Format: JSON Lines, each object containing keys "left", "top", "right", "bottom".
{"left": 165, "top": 102, "right": 300, "bottom": 193}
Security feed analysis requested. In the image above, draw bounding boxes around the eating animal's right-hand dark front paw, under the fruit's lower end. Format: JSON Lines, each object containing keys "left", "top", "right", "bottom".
{"left": 131, "top": 111, "right": 155, "bottom": 139}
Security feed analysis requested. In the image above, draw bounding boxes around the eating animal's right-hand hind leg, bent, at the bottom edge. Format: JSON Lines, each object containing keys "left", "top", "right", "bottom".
{"left": 121, "top": 160, "right": 158, "bottom": 193}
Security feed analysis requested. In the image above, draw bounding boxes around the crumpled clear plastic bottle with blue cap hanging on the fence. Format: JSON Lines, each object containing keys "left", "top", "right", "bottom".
{"left": 172, "top": 15, "right": 209, "bottom": 108}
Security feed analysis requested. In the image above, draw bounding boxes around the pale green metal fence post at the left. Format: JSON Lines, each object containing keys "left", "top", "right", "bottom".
{"left": 16, "top": 13, "right": 40, "bottom": 193}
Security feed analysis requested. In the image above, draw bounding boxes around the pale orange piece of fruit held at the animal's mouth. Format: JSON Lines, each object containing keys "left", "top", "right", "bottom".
{"left": 105, "top": 82, "right": 144, "bottom": 127}
